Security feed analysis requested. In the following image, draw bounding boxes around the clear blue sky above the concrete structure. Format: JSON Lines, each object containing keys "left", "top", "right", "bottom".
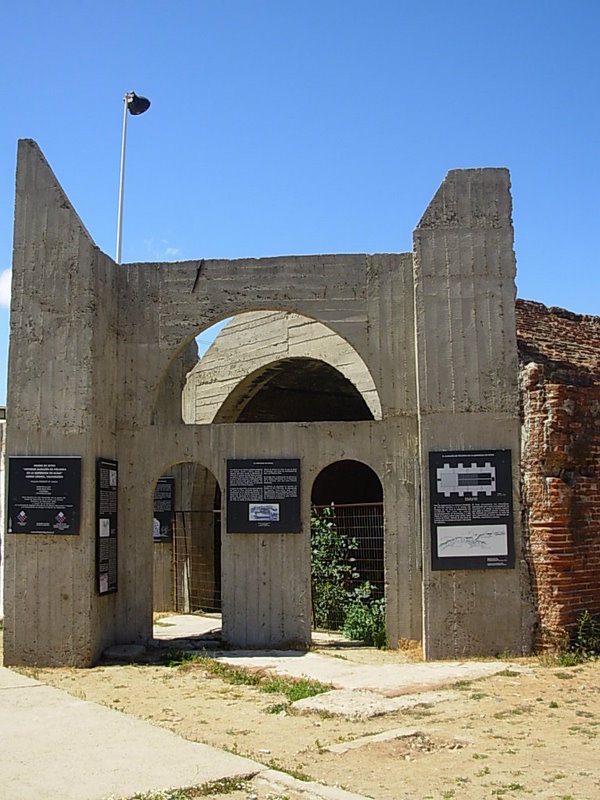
{"left": 0, "top": 0, "right": 600, "bottom": 403}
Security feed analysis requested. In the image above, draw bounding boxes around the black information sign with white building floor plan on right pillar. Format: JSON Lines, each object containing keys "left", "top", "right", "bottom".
{"left": 429, "top": 450, "right": 515, "bottom": 569}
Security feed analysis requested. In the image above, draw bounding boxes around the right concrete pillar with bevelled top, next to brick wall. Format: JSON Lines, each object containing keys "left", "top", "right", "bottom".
{"left": 414, "top": 169, "right": 522, "bottom": 658}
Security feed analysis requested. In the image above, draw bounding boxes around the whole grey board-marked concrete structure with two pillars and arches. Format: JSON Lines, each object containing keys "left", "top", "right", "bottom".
{"left": 4, "top": 140, "right": 530, "bottom": 665}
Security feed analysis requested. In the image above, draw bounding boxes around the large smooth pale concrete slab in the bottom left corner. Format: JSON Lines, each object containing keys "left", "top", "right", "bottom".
{"left": 0, "top": 667, "right": 256, "bottom": 800}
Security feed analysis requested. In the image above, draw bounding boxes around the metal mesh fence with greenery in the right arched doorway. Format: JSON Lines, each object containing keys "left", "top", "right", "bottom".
{"left": 311, "top": 503, "right": 385, "bottom": 631}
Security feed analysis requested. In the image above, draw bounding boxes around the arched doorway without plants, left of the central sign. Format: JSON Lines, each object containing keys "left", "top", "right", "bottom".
{"left": 153, "top": 463, "right": 221, "bottom": 615}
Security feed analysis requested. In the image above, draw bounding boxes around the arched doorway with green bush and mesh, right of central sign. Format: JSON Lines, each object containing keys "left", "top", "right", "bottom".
{"left": 311, "top": 460, "right": 385, "bottom": 644}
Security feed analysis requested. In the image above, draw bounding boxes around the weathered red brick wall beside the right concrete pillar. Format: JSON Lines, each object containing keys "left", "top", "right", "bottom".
{"left": 517, "top": 300, "right": 600, "bottom": 646}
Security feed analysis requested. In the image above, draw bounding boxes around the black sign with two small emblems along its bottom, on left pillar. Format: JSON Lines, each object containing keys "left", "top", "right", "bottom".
{"left": 8, "top": 456, "right": 81, "bottom": 534}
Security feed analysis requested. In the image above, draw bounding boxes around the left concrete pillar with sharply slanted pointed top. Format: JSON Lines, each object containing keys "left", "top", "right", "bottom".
{"left": 4, "top": 140, "right": 117, "bottom": 665}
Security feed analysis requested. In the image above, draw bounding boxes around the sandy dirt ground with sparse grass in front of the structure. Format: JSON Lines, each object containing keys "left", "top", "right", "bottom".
{"left": 4, "top": 636, "right": 600, "bottom": 800}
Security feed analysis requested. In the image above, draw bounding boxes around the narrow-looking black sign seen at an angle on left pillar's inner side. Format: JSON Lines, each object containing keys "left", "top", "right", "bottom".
{"left": 96, "top": 458, "right": 119, "bottom": 594}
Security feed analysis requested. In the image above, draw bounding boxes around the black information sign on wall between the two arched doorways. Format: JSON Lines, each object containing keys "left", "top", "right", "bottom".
{"left": 227, "top": 458, "right": 302, "bottom": 533}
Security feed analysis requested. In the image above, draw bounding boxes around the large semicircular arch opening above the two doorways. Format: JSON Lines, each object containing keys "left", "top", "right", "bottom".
{"left": 181, "top": 311, "right": 382, "bottom": 424}
